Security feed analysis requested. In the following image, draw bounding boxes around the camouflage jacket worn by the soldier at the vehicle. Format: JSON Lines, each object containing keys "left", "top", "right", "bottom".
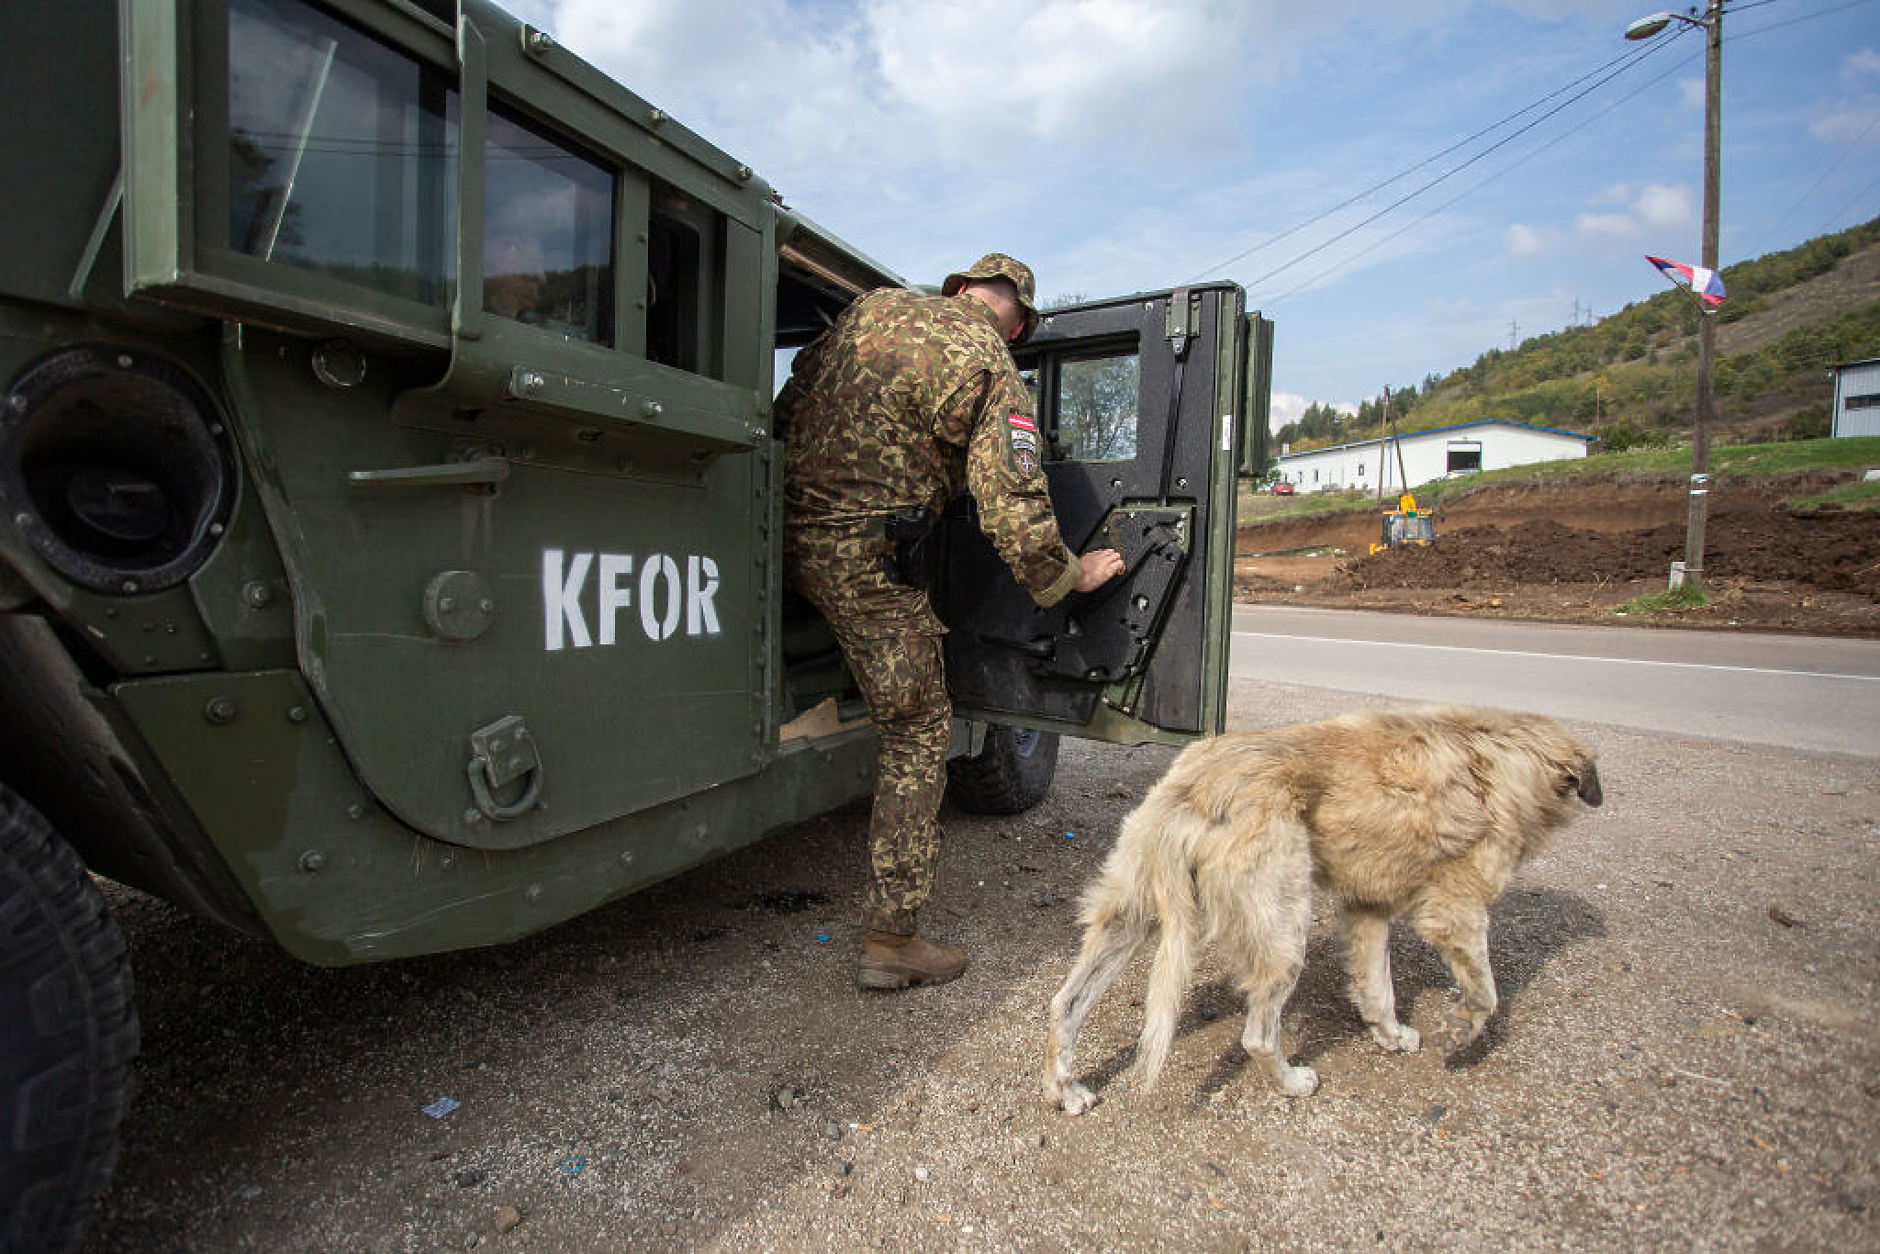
{"left": 776, "top": 288, "right": 1077, "bottom": 605}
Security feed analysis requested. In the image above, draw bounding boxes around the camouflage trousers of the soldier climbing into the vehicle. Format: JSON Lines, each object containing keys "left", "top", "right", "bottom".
{"left": 784, "top": 526, "right": 953, "bottom": 936}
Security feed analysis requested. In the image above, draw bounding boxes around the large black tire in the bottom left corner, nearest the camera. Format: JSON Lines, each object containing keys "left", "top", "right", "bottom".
{"left": 0, "top": 786, "right": 137, "bottom": 1254}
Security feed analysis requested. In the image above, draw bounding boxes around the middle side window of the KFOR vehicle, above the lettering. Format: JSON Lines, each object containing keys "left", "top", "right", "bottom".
{"left": 483, "top": 107, "right": 615, "bottom": 344}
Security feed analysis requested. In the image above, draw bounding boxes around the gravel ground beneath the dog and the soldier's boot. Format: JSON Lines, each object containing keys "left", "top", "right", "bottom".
{"left": 88, "top": 682, "right": 1880, "bottom": 1250}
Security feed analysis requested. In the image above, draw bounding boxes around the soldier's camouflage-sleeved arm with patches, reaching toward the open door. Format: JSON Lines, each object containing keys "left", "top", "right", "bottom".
{"left": 949, "top": 370, "right": 1083, "bottom": 605}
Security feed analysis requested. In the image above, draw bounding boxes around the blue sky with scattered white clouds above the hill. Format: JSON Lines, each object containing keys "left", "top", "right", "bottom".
{"left": 508, "top": 0, "right": 1880, "bottom": 425}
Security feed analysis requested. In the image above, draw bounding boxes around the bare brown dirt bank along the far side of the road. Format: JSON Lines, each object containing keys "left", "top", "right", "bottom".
{"left": 1235, "top": 479, "right": 1880, "bottom": 635}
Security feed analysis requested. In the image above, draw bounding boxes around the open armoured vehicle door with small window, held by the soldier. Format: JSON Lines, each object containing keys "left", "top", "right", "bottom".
{"left": 934, "top": 284, "right": 1271, "bottom": 743}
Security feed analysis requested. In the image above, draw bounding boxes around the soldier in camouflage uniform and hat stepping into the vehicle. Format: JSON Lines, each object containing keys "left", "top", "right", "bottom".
{"left": 776, "top": 252, "right": 1122, "bottom": 989}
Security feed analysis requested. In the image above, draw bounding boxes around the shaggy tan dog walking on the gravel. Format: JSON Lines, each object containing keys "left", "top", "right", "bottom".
{"left": 1045, "top": 705, "right": 1602, "bottom": 1115}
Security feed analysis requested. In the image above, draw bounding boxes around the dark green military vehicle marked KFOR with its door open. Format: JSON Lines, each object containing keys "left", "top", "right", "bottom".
{"left": 0, "top": 0, "right": 1269, "bottom": 1248}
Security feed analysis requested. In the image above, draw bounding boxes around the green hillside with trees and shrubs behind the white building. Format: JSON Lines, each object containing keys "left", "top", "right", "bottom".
{"left": 1273, "top": 218, "right": 1880, "bottom": 451}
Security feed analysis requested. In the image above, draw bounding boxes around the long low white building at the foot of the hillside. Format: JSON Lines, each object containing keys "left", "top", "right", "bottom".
{"left": 1278, "top": 424, "right": 1586, "bottom": 493}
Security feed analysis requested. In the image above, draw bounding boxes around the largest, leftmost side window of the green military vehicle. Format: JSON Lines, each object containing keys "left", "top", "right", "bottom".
{"left": 227, "top": 0, "right": 459, "bottom": 306}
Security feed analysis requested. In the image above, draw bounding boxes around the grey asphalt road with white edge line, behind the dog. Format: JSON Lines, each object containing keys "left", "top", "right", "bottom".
{"left": 1233, "top": 605, "right": 1880, "bottom": 758}
